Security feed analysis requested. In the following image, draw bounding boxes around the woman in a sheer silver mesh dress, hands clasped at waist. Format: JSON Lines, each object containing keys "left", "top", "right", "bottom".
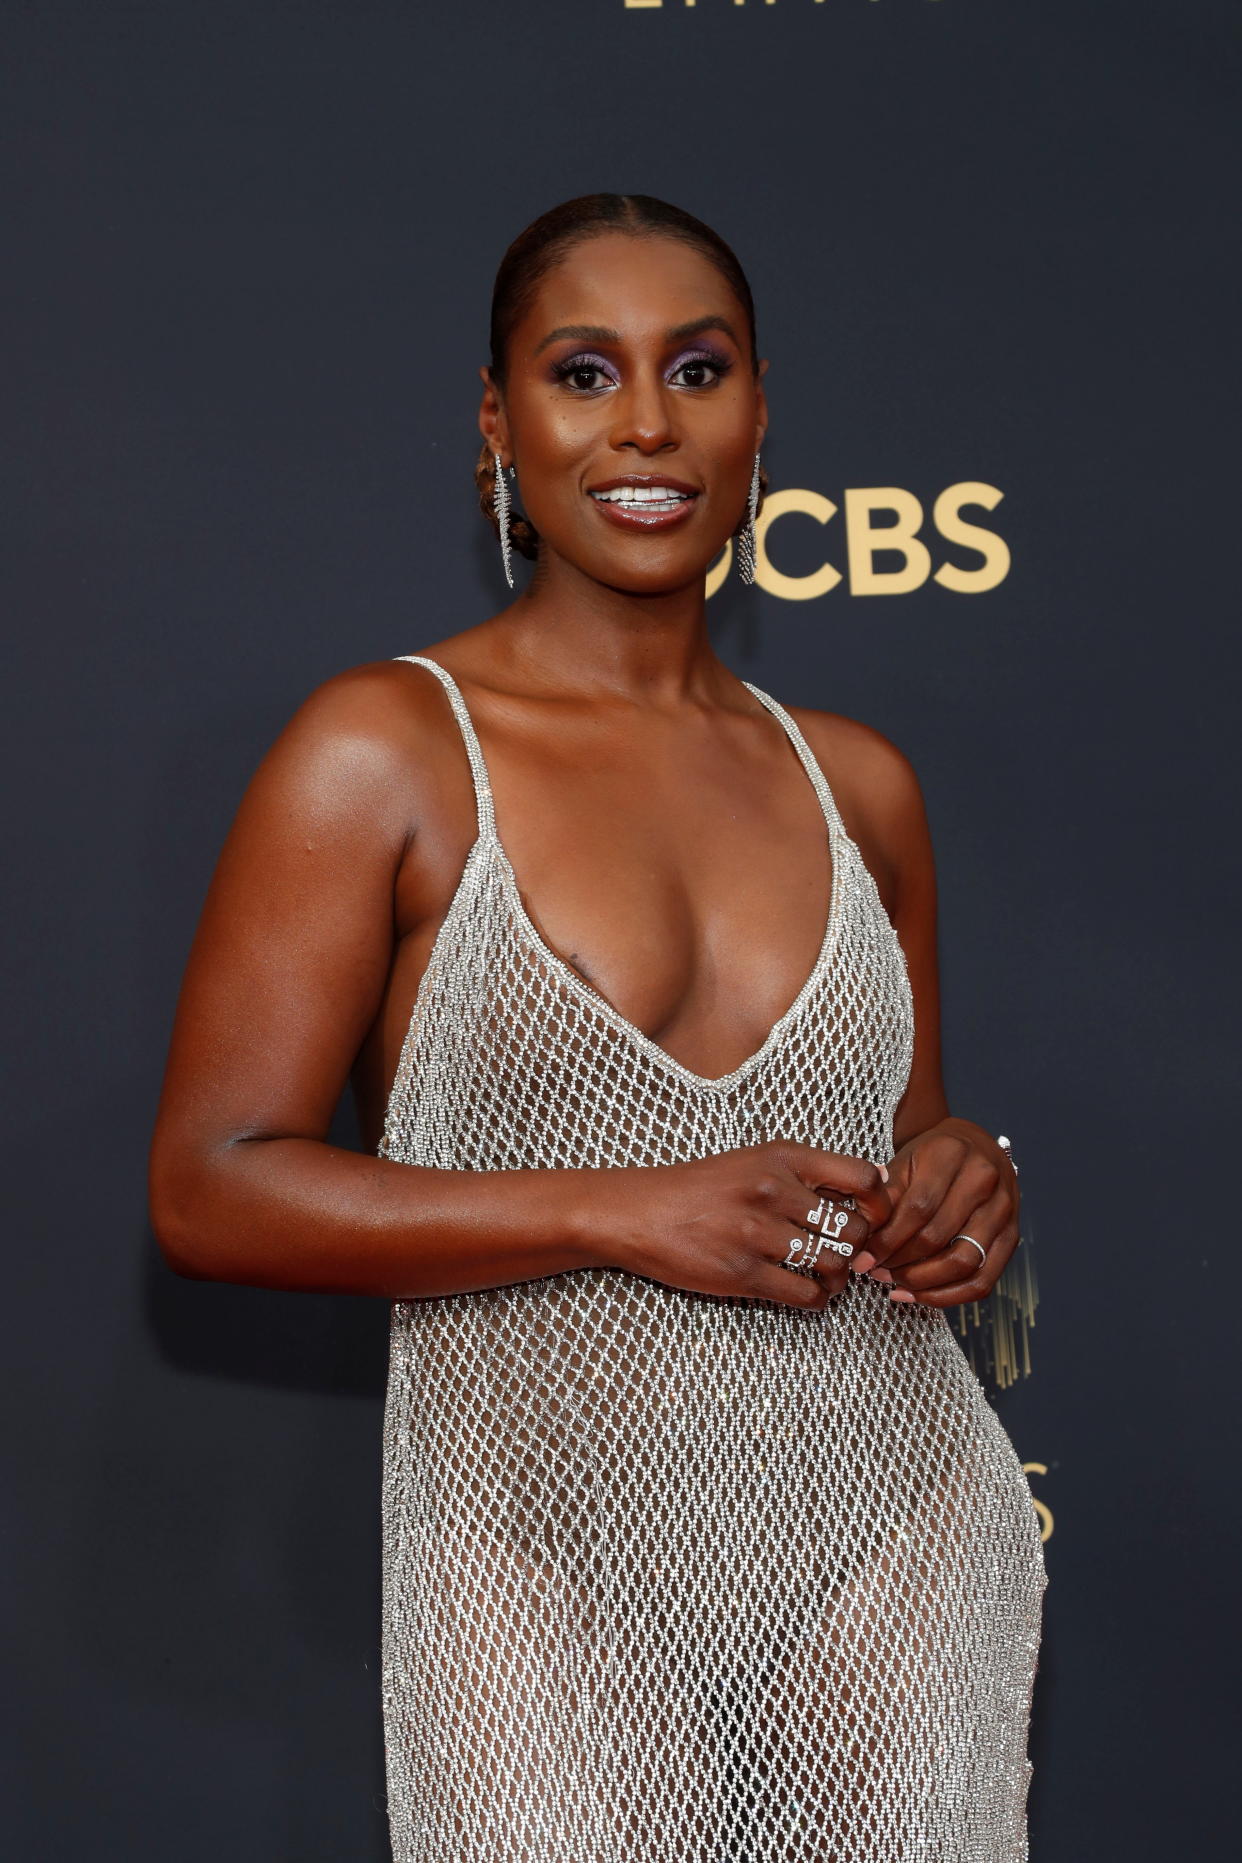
{"left": 151, "top": 196, "right": 1045, "bottom": 1863}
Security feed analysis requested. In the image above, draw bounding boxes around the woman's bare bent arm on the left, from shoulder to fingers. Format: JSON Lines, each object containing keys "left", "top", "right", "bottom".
{"left": 149, "top": 665, "right": 888, "bottom": 1306}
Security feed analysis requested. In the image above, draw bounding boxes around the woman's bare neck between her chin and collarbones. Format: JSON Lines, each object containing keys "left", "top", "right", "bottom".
{"left": 492, "top": 559, "right": 736, "bottom": 706}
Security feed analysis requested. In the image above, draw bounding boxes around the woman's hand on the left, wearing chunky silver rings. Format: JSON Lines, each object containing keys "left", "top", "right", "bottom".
{"left": 587, "top": 1140, "right": 892, "bottom": 1308}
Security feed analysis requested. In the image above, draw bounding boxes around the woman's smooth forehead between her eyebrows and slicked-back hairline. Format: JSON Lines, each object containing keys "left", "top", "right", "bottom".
{"left": 514, "top": 233, "right": 747, "bottom": 352}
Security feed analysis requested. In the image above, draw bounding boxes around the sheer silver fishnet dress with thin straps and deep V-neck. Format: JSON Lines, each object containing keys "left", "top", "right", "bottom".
{"left": 380, "top": 654, "right": 1045, "bottom": 1863}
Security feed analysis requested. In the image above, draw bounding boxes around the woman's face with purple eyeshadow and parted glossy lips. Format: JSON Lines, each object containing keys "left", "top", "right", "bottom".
{"left": 479, "top": 233, "right": 767, "bottom": 594}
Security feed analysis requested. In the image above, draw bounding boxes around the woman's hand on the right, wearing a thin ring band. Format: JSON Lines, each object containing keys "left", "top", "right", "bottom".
{"left": 860, "top": 1120, "right": 1019, "bottom": 1306}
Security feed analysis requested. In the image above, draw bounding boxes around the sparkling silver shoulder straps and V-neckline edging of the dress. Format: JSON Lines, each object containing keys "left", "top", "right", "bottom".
{"left": 397, "top": 654, "right": 849, "bottom": 1092}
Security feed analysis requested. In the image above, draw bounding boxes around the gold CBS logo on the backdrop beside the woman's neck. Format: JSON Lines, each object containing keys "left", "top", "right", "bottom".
{"left": 708, "top": 479, "right": 1011, "bottom": 602}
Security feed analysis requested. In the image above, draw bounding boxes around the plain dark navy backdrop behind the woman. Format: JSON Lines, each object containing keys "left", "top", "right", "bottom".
{"left": 0, "top": 0, "right": 1238, "bottom": 1863}
